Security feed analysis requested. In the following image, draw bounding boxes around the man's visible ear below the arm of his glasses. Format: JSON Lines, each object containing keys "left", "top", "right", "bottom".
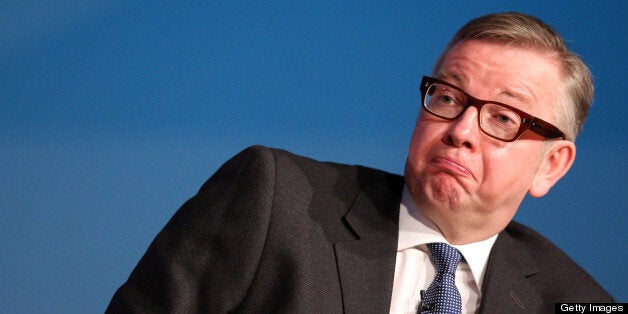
{"left": 529, "top": 140, "right": 576, "bottom": 197}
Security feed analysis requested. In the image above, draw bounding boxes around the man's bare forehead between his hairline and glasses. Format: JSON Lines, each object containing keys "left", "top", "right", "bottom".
{"left": 435, "top": 40, "right": 560, "bottom": 107}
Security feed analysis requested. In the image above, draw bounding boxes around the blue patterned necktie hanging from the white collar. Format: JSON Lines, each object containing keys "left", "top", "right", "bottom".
{"left": 421, "top": 243, "right": 463, "bottom": 314}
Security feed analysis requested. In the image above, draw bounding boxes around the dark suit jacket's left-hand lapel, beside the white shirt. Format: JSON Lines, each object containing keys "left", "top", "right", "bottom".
{"left": 334, "top": 172, "right": 403, "bottom": 313}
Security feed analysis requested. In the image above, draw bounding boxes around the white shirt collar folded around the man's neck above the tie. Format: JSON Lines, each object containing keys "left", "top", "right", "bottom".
{"left": 397, "top": 187, "right": 497, "bottom": 288}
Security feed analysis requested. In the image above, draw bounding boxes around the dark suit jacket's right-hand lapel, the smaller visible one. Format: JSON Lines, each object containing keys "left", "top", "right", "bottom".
{"left": 479, "top": 227, "right": 542, "bottom": 313}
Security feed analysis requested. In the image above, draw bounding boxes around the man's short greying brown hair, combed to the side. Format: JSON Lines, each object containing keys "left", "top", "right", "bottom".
{"left": 434, "top": 12, "right": 593, "bottom": 141}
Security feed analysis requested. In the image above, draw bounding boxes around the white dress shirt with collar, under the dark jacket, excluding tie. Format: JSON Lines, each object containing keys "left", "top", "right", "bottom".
{"left": 390, "top": 187, "right": 497, "bottom": 314}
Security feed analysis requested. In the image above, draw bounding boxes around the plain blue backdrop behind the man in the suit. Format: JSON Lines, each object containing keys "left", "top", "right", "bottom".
{"left": 0, "top": 1, "right": 628, "bottom": 313}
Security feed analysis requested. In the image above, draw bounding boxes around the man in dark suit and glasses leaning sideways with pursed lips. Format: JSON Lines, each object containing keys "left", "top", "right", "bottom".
{"left": 108, "top": 13, "right": 613, "bottom": 313}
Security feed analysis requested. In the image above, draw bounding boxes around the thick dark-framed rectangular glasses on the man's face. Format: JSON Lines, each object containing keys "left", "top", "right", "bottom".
{"left": 421, "top": 76, "right": 565, "bottom": 142}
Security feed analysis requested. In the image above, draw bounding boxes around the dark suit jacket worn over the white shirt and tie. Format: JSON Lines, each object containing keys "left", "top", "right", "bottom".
{"left": 107, "top": 146, "right": 613, "bottom": 313}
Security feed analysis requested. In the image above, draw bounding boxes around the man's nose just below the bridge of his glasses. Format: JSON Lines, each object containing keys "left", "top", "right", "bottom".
{"left": 443, "top": 106, "right": 480, "bottom": 149}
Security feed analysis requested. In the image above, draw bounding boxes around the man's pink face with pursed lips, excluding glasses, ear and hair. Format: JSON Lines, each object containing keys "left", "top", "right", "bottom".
{"left": 405, "top": 40, "right": 560, "bottom": 240}
